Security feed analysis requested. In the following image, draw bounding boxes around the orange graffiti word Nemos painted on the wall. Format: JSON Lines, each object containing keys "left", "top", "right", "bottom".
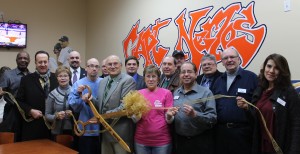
{"left": 175, "top": 2, "right": 266, "bottom": 68}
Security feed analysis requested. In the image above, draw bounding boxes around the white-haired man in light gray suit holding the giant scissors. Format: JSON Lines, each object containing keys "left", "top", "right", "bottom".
{"left": 97, "top": 55, "right": 136, "bottom": 154}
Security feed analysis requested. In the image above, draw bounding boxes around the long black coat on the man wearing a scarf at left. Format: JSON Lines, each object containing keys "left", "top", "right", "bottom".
{"left": 17, "top": 72, "right": 58, "bottom": 141}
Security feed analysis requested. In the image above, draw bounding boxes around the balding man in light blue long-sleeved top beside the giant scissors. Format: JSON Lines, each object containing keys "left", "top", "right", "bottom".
{"left": 68, "top": 58, "right": 102, "bottom": 154}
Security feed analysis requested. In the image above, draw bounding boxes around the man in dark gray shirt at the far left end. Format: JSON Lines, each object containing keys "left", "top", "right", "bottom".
{"left": 0, "top": 51, "right": 30, "bottom": 141}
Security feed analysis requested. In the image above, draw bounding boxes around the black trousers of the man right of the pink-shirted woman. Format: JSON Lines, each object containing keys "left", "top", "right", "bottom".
{"left": 174, "top": 129, "right": 214, "bottom": 154}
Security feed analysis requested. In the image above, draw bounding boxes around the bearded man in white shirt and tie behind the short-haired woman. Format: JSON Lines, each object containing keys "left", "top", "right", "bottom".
{"left": 68, "top": 51, "right": 86, "bottom": 86}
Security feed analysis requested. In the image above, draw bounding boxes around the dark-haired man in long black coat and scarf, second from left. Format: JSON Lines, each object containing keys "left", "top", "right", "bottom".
{"left": 17, "top": 51, "right": 58, "bottom": 141}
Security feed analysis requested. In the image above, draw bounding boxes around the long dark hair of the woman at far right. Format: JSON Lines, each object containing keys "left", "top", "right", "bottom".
{"left": 258, "top": 53, "right": 292, "bottom": 90}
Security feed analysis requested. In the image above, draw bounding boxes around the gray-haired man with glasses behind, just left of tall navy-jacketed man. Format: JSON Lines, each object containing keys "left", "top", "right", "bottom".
{"left": 196, "top": 54, "right": 222, "bottom": 89}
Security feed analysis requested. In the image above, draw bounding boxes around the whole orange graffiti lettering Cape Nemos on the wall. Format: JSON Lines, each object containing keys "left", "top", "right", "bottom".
{"left": 123, "top": 1, "right": 267, "bottom": 71}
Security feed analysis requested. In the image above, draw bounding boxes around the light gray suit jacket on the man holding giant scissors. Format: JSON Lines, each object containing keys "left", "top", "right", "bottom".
{"left": 96, "top": 73, "right": 136, "bottom": 145}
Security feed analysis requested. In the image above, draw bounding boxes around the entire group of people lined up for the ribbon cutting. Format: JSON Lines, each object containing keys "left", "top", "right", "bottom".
{"left": 0, "top": 43, "right": 300, "bottom": 154}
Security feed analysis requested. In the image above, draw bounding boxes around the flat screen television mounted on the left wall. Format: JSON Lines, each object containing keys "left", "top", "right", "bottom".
{"left": 0, "top": 22, "right": 27, "bottom": 48}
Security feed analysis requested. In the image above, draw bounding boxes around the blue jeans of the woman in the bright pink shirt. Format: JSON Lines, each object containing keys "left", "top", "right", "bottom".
{"left": 134, "top": 143, "right": 172, "bottom": 154}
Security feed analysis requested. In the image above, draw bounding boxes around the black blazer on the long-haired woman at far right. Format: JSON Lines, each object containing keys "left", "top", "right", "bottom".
{"left": 248, "top": 86, "right": 300, "bottom": 154}
